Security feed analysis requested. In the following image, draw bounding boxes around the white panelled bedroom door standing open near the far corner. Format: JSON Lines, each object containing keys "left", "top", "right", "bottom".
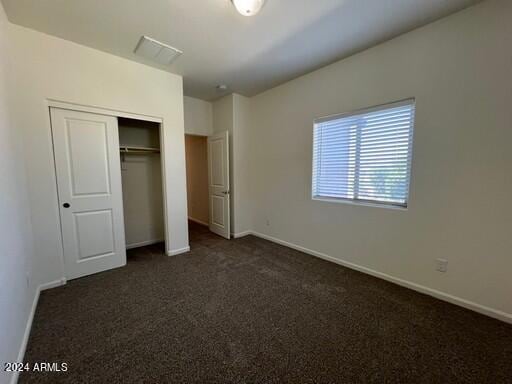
{"left": 208, "top": 131, "right": 230, "bottom": 239}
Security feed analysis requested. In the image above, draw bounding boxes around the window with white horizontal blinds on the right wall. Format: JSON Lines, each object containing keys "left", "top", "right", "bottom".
{"left": 313, "top": 99, "right": 414, "bottom": 207}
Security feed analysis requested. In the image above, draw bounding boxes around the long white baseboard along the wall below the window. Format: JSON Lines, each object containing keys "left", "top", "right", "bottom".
{"left": 250, "top": 231, "right": 512, "bottom": 324}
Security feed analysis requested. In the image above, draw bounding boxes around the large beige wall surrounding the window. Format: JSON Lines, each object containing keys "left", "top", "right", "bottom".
{"left": 246, "top": 0, "right": 512, "bottom": 320}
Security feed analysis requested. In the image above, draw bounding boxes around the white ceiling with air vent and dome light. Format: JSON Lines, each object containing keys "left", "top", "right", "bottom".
{"left": 2, "top": 0, "right": 480, "bottom": 100}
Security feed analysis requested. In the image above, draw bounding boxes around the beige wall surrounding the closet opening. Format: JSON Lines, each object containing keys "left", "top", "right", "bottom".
{"left": 9, "top": 24, "right": 188, "bottom": 284}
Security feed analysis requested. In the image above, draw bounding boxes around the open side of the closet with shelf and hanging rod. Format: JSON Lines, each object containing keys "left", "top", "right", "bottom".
{"left": 118, "top": 117, "right": 165, "bottom": 255}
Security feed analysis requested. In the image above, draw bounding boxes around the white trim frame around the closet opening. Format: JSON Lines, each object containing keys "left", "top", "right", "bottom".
{"left": 46, "top": 99, "right": 169, "bottom": 284}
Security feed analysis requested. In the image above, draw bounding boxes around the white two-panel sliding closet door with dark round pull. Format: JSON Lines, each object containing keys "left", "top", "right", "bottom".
{"left": 51, "top": 108, "right": 126, "bottom": 279}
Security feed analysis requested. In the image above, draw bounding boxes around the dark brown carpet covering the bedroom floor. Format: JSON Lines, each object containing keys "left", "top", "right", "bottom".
{"left": 20, "top": 225, "right": 512, "bottom": 384}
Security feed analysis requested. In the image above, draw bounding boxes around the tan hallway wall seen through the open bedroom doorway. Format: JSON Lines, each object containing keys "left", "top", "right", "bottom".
{"left": 185, "top": 135, "right": 209, "bottom": 225}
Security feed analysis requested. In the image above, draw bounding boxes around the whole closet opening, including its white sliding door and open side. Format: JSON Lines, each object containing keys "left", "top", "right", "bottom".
{"left": 48, "top": 100, "right": 168, "bottom": 280}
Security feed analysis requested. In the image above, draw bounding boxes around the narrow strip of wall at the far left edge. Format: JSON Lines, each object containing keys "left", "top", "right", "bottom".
{"left": 0, "top": 3, "right": 36, "bottom": 383}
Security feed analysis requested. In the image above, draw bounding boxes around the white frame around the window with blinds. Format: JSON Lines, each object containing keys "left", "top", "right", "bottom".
{"left": 310, "top": 97, "right": 416, "bottom": 210}
